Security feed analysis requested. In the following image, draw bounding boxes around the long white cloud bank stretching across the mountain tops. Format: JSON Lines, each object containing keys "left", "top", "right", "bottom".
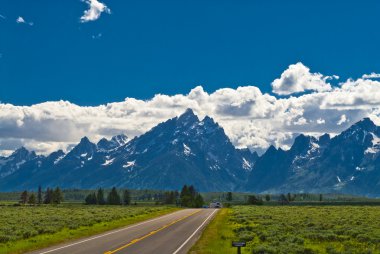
{"left": 0, "top": 63, "right": 380, "bottom": 154}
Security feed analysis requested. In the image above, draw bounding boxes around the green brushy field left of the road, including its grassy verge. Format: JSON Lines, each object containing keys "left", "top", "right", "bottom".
{"left": 0, "top": 204, "right": 178, "bottom": 254}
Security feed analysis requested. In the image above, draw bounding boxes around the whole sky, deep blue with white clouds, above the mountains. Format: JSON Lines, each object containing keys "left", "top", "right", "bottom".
{"left": 0, "top": 0, "right": 380, "bottom": 154}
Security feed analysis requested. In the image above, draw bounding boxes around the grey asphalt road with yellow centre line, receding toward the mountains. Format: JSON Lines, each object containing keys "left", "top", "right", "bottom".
{"left": 31, "top": 209, "right": 218, "bottom": 254}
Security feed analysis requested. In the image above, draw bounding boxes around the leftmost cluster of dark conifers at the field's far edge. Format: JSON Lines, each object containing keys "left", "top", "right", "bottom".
{"left": 20, "top": 186, "right": 64, "bottom": 205}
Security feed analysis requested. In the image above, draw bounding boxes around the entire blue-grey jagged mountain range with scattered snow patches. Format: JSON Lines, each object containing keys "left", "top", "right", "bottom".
{"left": 0, "top": 109, "right": 380, "bottom": 196}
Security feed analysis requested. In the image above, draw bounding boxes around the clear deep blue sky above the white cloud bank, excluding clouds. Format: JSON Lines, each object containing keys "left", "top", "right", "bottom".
{"left": 0, "top": 0, "right": 380, "bottom": 105}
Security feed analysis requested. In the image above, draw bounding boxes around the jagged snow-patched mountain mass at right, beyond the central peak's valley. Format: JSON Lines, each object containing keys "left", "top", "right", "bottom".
{"left": 246, "top": 118, "right": 380, "bottom": 196}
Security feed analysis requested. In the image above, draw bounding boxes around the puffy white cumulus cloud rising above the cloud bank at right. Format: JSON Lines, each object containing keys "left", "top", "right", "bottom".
{"left": 272, "top": 63, "right": 339, "bottom": 95}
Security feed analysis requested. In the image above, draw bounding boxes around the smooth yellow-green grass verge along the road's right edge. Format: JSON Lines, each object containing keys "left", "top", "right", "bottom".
{"left": 189, "top": 208, "right": 236, "bottom": 254}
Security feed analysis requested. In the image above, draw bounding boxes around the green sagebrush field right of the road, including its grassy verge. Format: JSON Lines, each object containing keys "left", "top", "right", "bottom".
{"left": 190, "top": 206, "right": 380, "bottom": 254}
